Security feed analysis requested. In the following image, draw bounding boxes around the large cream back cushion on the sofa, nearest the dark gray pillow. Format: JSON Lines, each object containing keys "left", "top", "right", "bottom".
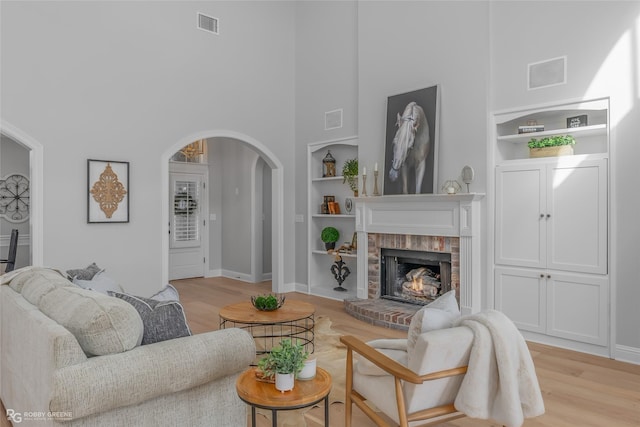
{"left": 38, "top": 287, "right": 143, "bottom": 356}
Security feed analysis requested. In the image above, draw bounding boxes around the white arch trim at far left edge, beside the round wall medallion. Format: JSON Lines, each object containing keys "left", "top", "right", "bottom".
{"left": 0, "top": 120, "right": 44, "bottom": 266}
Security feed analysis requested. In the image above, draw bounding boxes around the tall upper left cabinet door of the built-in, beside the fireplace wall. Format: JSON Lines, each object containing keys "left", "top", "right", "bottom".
{"left": 495, "top": 165, "right": 546, "bottom": 267}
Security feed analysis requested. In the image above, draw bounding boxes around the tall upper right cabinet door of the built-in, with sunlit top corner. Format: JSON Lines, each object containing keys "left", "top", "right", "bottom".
{"left": 545, "top": 158, "right": 608, "bottom": 274}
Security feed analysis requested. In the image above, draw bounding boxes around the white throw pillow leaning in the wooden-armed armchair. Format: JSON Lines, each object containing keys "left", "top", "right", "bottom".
{"left": 407, "top": 290, "right": 460, "bottom": 357}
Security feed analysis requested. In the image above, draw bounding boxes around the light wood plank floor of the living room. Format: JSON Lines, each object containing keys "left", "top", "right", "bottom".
{"left": 0, "top": 278, "right": 640, "bottom": 427}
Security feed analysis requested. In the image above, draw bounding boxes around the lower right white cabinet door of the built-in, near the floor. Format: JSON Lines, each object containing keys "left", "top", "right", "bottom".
{"left": 547, "top": 272, "right": 609, "bottom": 345}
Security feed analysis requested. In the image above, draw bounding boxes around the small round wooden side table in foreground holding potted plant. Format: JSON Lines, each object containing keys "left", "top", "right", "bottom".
{"left": 236, "top": 368, "right": 331, "bottom": 427}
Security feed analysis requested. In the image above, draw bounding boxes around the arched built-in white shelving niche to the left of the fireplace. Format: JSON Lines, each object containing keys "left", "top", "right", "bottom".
{"left": 300, "top": 137, "right": 358, "bottom": 300}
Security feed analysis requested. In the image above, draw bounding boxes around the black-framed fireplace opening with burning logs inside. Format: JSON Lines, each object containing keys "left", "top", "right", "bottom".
{"left": 380, "top": 248, "right": 451, "bottom": 305}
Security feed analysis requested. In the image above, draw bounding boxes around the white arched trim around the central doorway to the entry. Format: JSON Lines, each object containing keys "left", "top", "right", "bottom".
{"left": 161, "top": 130, "right": 284, "bottom": 292}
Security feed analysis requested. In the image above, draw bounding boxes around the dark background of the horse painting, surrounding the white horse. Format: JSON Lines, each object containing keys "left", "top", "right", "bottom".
{"left": 382, "top": 85, "right": 440, "bottom": 195}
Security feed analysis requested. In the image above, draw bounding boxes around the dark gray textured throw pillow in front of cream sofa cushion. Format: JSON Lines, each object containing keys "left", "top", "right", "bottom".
{"left": 109, "top": 292, "right": 191, "bottom": 345}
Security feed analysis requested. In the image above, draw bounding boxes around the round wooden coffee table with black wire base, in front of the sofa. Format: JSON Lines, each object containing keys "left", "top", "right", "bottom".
{"left": 219, "top": 299, "right": 316, "bottom": 354}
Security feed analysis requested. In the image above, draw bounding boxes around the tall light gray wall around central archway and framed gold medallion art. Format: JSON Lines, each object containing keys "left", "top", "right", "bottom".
{"left": 0, "top": 1, "right": 294, "bottom": 295}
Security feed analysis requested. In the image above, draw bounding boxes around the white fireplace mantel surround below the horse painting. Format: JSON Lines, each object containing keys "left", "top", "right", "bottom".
{"left": 355, "top": 193, "right": 484, "bottom": 314}
